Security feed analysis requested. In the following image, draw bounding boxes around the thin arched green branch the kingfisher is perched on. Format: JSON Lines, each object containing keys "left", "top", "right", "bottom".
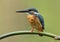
{"left": 0, "top": 31, "right": 60, "bottom": 40}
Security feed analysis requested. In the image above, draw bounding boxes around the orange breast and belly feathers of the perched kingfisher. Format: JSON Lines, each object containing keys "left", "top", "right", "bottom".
{"left": 27, "top": 15, "right": 42, "bottom": 30}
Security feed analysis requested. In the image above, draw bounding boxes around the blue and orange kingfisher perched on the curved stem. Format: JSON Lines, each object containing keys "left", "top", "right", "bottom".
{"left": 16, "top": 8, "right": 44, "bottom": 32}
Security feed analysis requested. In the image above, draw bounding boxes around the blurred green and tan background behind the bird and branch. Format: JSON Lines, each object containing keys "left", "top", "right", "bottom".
{"left": 0, "top": 0, "right": 60, "bottom": 42}
